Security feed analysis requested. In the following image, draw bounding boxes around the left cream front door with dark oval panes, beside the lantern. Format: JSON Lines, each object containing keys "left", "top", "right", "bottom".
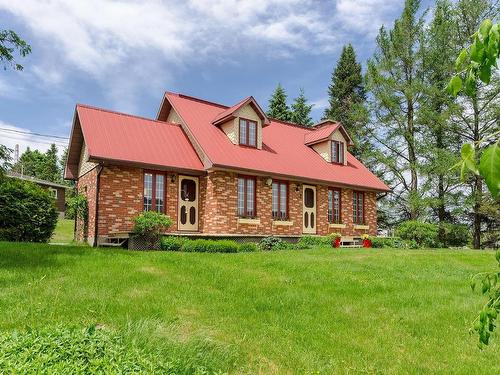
{"left": 178, "top": 176, "right": 198, "bottom": 231}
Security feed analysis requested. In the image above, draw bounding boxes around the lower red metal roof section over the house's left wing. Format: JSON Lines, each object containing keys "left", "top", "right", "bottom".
{"left": 76, "top": 104, "right": 203, "bottom": 172}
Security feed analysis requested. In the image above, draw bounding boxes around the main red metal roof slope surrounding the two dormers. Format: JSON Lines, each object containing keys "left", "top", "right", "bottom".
{"left": 165, "top": 93, "right": 389, "bottom": 191}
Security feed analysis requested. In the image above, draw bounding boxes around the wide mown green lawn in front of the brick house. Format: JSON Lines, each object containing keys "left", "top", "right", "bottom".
{"left": 0, "top": 243, "right": 500, "bottom": 374}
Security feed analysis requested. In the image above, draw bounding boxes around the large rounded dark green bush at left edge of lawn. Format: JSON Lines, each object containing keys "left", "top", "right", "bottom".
{"left": 0, "top": 178, "right": 57, "bottom": 242}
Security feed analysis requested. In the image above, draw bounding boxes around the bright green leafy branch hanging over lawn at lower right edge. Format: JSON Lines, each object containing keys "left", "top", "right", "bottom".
{"left": 471, "top": 251, "right": 500, "bottom": 348}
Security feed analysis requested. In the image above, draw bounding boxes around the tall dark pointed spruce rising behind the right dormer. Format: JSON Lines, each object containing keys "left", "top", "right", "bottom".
{"left": 323, "top": 44, "right": 368, "bottom": 157}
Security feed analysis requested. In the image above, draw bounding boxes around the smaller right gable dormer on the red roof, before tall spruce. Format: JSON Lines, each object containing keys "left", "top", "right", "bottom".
{"left": 304, "top": 120, "right": 353, "bottom": 165}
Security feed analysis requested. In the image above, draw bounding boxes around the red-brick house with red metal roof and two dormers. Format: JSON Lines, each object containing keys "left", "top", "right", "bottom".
{"left": 65, "top": 92, "right": 389, "bottom": 245}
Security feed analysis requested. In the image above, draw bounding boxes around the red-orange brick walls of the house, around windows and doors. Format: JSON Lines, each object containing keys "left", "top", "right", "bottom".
{"left": 76, "top": 166, "right": 377, "bottom": 244}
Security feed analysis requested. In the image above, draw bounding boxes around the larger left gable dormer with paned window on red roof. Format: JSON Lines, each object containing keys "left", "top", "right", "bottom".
{"left": 212, "top": 96, "right": 270, "bottom": 149}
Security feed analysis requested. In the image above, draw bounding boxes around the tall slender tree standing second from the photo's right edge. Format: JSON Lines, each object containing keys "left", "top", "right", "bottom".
{"left": 418, "top": 0, "right": 461, "bottom": 243}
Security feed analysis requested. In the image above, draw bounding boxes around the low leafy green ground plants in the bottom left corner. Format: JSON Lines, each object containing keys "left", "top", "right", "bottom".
{"left": 0, "top": 326, "right": 221, "bottom": 374}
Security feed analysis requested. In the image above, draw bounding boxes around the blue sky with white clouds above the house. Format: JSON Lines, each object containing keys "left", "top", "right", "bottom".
{"left": 0, "top": 0, "right": 430, "bottom": 157}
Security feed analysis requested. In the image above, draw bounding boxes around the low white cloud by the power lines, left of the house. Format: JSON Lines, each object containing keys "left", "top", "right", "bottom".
{"left": 0, "top": 120, "right": 68, "bottom": 157}
